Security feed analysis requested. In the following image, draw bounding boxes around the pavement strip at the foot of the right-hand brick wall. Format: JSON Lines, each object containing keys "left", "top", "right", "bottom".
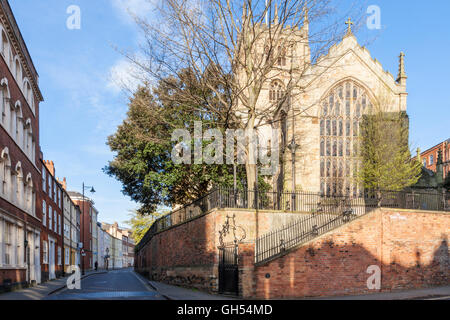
{"left": 307, "top": 286, "right": 450, "bottom": 300}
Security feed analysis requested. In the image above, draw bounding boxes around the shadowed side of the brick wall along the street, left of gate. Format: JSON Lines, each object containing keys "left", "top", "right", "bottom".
{"left": 135, "top": 215, "right": 217, "bottom": 291}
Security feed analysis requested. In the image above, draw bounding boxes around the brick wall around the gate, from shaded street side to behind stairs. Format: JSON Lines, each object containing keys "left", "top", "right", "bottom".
{"left": 135, "top": 210, "right": 348, "bottom": 292}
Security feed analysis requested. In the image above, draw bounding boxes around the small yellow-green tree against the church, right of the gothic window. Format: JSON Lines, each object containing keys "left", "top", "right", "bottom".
{"left": 356, "top": 94, "right": 422, "bottom": 205}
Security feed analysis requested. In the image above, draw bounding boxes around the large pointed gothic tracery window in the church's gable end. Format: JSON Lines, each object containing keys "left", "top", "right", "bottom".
{"left": 320, "top": 80, "right": 372, "bottom": 197}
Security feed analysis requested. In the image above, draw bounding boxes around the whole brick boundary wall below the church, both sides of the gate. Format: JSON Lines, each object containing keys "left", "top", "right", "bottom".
{"left": 136, "top": 209, "right": 450, "bottom": 299}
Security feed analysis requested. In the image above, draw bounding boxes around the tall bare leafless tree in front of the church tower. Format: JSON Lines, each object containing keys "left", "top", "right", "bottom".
{"left": 121, "top": 0, "right": 364, "bottom": 187}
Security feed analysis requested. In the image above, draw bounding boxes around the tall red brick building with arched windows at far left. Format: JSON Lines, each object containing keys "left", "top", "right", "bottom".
{"left": 0, "top": 0, "right": 43, "bottom": 291}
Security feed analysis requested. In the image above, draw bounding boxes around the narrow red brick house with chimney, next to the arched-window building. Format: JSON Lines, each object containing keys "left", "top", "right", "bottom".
{"left": 41, "top": 161, "right": 64, "bottom": 281}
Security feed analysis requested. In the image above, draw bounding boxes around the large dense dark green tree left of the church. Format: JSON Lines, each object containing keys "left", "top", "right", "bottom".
{"left": 104, "top": 69, "right": 255, "bottom": 214}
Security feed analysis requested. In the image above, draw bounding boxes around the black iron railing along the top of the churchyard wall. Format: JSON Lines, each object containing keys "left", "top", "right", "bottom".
{"left": 136, "top": 187, "right": 450, "bottom": 250}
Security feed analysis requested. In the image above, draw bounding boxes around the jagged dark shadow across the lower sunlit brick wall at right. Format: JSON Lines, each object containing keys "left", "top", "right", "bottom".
{"left": 255, "top": 234, "right": 450, "bottom": 299}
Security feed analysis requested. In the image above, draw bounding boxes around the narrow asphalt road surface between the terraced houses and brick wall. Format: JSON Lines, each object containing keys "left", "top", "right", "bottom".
{"left": 45, "top": 269, "right": 165, "bottom": 300}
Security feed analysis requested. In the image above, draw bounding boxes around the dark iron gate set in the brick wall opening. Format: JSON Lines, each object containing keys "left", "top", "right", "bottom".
{"left": 219, "top": 246, "right": 239, "bottom": 295}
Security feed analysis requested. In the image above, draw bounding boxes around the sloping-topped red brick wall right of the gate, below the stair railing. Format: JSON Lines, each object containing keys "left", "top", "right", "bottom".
{"left": 251, "top": 210, "right": 450, "bottom": 299}
